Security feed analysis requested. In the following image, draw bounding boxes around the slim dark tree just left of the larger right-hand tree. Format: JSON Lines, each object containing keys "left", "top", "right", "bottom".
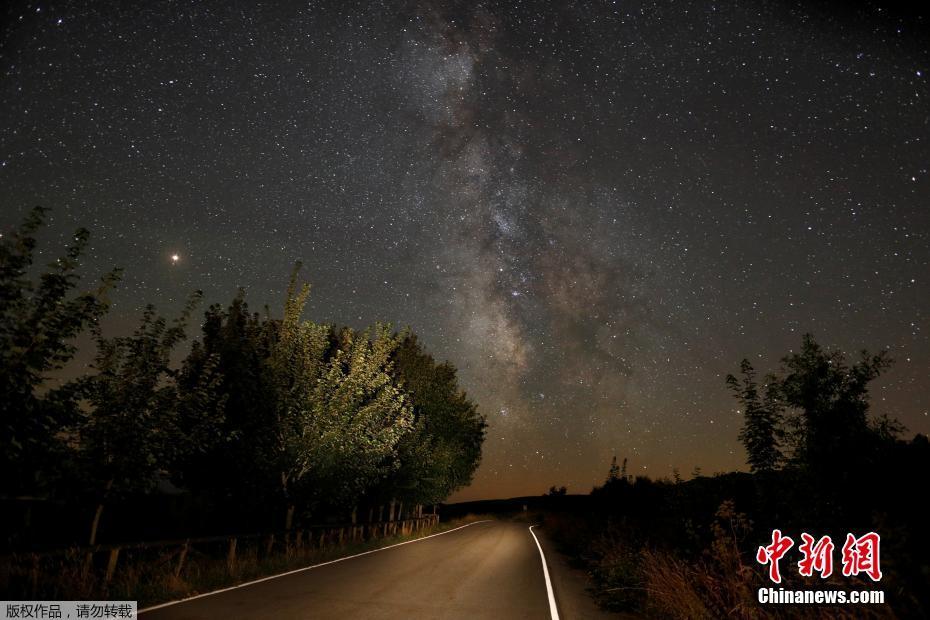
{"left": 726, "top": 359, "right": 782, "bottom": 472}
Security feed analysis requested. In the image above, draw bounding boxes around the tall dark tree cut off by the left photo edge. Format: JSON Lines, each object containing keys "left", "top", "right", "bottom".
{"left": 0, "top": 207, "right": 120, "bottom": 494}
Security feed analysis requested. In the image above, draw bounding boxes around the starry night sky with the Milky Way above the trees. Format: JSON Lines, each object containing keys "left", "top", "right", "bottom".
{"left": 0, "top": 0, "right": 930, "bottom": 499}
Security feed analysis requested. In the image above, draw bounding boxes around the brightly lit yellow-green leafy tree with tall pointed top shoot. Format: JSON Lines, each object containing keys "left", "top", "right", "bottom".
{"left": 270, "top": 266, "right": 412, "bottom": 528}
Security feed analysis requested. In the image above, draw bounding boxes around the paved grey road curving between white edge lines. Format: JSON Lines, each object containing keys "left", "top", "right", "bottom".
{"left": 141, "top": 521, "right": 550, "bottom": 620}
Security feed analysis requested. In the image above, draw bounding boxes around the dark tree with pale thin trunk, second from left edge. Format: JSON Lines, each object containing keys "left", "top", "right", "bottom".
{"left": 74, "top": 293, "right": 200, "bottom": 545}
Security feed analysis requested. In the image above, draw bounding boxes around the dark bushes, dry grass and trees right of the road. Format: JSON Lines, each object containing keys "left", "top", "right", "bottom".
{"left": 536, "top": 336, "right": 930, "bottom": 618}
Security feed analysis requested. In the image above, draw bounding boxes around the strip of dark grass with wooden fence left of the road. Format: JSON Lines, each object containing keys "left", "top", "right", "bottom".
{"left": 0, "top": 515, "right": 493, "bottom": 609}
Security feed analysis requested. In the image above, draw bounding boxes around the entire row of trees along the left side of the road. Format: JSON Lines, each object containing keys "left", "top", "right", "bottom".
{"left": 0, "top": 208, "right": 486, "bottom": 544}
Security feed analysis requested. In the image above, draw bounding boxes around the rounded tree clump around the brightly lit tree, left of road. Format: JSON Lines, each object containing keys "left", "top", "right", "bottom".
{"left": 176, "top": 265, "right": 485, "bottom": 523}
